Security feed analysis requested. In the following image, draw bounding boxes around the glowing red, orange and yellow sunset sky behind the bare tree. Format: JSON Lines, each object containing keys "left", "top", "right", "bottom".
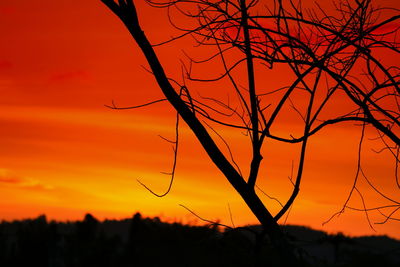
{"left": 0, "top": 0, "right": 400, "bottom": 238}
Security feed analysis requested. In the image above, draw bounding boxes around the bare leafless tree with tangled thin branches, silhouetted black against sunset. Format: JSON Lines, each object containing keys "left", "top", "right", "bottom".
{"left": 101, "top": 0, "right": 400, "bottom": 266}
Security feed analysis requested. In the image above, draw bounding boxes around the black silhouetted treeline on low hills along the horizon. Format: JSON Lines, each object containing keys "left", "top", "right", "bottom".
{"left": 0, "top": 213, "right": 400, "bottom": 267}
